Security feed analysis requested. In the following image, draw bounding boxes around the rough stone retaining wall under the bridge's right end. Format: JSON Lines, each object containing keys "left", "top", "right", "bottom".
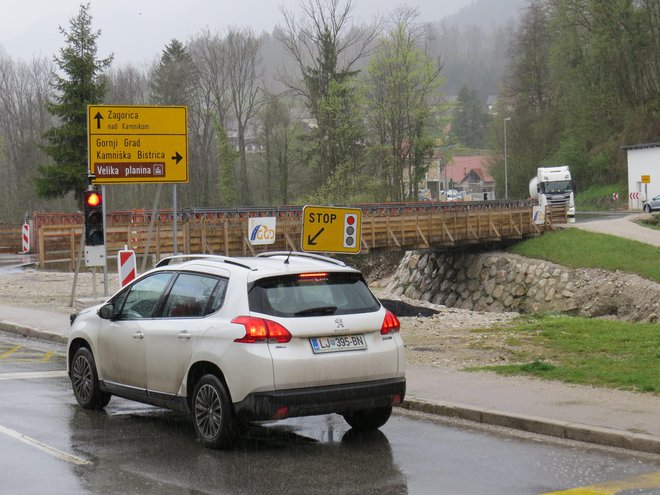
{"left": 387, "top": 251, "right": 660, "bottom": 322}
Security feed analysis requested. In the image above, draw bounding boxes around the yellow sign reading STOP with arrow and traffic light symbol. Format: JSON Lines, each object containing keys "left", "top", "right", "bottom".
{"left": 302, "top": 206, "right": 362, "bottom": 254}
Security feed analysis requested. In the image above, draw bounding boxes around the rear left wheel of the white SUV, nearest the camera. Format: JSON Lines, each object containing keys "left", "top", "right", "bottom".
{"left": 191, "top": 375, "right": 238, "bottom": 449}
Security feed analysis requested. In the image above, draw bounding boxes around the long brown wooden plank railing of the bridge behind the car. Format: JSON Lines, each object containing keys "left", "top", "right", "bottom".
{"left": 33, "top": 205, "right": 547, "bottom": 269}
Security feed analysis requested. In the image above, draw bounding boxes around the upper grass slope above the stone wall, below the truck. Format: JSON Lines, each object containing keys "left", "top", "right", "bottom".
{"left": 508, "top": 228, "right": 660, "bottom": 282}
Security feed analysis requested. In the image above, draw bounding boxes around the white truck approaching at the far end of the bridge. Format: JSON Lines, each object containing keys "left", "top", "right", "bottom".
{"left": 529, "top": 165, "right": 575, "bottom": 217}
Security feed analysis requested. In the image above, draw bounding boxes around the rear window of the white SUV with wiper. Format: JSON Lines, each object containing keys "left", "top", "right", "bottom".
{"left": 248, "top": 273, "right": 380, "bottom": 317}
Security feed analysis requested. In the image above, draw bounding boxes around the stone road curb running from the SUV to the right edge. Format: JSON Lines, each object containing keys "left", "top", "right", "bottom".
{"left": 401, "top": 396, "right": 660, "bottom": 454}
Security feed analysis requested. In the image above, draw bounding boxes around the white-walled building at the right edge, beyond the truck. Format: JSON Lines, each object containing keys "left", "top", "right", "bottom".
{"left": 623, "top": 143, "right": 660, "bottom": 210}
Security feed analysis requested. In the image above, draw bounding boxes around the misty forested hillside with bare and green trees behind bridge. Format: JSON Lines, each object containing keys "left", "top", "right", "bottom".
{"left": 0, "top": 0, "right": 660, "bottom": 222}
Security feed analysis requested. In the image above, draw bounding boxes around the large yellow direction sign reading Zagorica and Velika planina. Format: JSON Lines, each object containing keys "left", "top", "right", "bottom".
{"left": 87, "top": 105, "right": 188, "bottom": 184}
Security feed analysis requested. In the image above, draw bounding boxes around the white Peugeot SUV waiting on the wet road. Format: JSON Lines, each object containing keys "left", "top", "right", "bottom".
{"left": 67, "top": 252, "right": 406, "bottom": 448}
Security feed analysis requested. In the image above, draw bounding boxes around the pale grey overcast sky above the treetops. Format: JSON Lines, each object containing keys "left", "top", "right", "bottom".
{"left": 0, "top": 0, "right": 474, "bottom": 66}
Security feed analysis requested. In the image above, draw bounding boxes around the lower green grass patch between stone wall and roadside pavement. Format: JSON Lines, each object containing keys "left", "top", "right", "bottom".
{"left": 471, "top": 315, "right": 660, "bottom": 394}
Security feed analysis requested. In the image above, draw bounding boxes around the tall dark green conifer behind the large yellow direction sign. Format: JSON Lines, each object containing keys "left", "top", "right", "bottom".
{"left": 36, "top": 4, "right": 112, "bottom": 199}
